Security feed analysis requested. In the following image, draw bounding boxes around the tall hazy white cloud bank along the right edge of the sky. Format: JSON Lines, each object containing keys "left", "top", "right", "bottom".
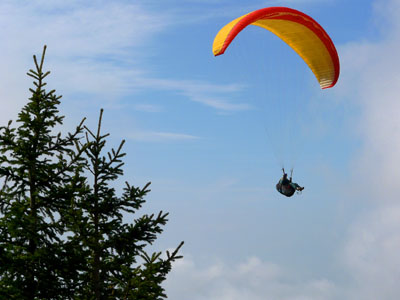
{"left": 340, "top": 0, "right": 400, "bottom": 300}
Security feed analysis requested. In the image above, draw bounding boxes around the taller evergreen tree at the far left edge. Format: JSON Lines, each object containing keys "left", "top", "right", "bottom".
{"left": 0, "top": 47, "right": 84, "bottom": 300}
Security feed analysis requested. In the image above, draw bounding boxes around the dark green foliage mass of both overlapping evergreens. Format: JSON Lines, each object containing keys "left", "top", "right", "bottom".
{"left": 0, "top": 48, "right": 183, "bottom": 300}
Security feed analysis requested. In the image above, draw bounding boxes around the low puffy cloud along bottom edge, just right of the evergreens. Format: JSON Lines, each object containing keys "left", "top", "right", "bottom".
{"left": 165, "top": 254, "right": 336, "bottom": 300}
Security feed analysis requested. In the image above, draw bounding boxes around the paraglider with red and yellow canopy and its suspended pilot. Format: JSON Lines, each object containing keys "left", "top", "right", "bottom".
{"left": 212, "top": 7, "right": 340, "bottom": 197}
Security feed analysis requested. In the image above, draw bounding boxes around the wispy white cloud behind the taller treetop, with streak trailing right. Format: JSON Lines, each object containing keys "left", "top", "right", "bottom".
{"left": 0, "top": 1, "right": 248, "bottom": 127}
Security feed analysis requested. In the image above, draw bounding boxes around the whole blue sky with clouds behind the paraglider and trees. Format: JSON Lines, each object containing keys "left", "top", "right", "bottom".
{"left": 0, "top": 0, "right": 400, "bottom": 300}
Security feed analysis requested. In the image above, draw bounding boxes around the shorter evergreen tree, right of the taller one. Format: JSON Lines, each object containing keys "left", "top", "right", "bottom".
{"left": 69, "top": 110, "right": 183, "bottom": 300}
